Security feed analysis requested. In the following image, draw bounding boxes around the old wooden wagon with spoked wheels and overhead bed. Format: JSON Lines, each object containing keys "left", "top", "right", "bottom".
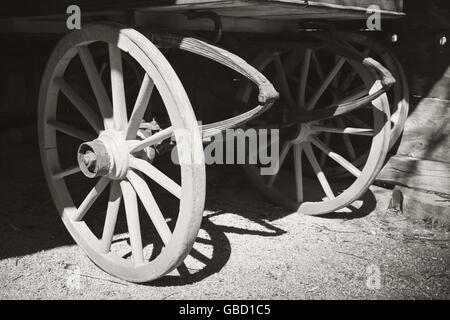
{"left": 1, "top": 0, "right": 408, "bottom": 282}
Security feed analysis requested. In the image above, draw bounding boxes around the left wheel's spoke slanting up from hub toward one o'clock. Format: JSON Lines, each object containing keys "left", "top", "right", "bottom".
{"left": 126, "top": 74, "right": 154, "bottom": 140}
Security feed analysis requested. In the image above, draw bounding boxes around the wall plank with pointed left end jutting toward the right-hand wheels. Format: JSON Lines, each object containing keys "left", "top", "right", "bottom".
{"left": 377, "top": 155, "right": 450, "bottom": 195}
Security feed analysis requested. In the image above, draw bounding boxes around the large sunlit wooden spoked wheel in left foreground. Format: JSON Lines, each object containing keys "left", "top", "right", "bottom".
{"left": 38, "top": 24, "right": 205, "bottom": 282}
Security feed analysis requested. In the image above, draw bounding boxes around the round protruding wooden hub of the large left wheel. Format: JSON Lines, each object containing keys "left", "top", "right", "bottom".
{"left": 77, "top": 130, "right": 129, "bottom": 180}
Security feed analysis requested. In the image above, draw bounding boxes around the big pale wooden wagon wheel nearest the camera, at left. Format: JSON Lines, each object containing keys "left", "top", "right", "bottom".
{"left": 38, "top": 24, "right": 205, "bottom": 282}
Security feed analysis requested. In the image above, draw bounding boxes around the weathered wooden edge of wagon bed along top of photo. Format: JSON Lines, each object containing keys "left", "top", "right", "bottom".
{"left": 0, "top": 0, "right": 403, "bottom": 19}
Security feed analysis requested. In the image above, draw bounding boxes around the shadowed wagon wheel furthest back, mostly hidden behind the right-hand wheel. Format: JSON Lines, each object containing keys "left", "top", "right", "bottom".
{"left": 238, "top": 32, "right": 409, "bottom": 177}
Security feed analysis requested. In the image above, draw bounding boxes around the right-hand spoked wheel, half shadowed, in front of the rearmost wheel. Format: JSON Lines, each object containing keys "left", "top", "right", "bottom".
{"left": 239, "top": 48, "right": 390, "bottom": 215}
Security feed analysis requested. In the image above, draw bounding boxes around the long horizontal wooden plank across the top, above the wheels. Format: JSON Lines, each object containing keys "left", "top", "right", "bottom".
{"left": 0, "top": 0, "right": 403, "bottom": 19}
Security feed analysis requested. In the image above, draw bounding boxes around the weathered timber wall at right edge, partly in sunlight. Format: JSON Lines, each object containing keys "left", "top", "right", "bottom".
{"left": 378, "top": 0, "right": 450, "bottom": 222}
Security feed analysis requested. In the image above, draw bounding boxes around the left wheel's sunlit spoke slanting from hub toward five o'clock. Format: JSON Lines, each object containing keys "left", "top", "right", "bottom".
{"left": 127, "top": 171, "right": 172, "bottom": 245}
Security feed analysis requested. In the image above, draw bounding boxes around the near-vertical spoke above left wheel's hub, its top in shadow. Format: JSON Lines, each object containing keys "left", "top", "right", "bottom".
{"left": 108, "top": 44, "right": 128, "bottom": 130}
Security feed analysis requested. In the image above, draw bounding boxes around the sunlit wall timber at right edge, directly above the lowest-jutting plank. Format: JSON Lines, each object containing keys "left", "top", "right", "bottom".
{"left": 397, "top": 98, "right": 450, "bottom": 163}
